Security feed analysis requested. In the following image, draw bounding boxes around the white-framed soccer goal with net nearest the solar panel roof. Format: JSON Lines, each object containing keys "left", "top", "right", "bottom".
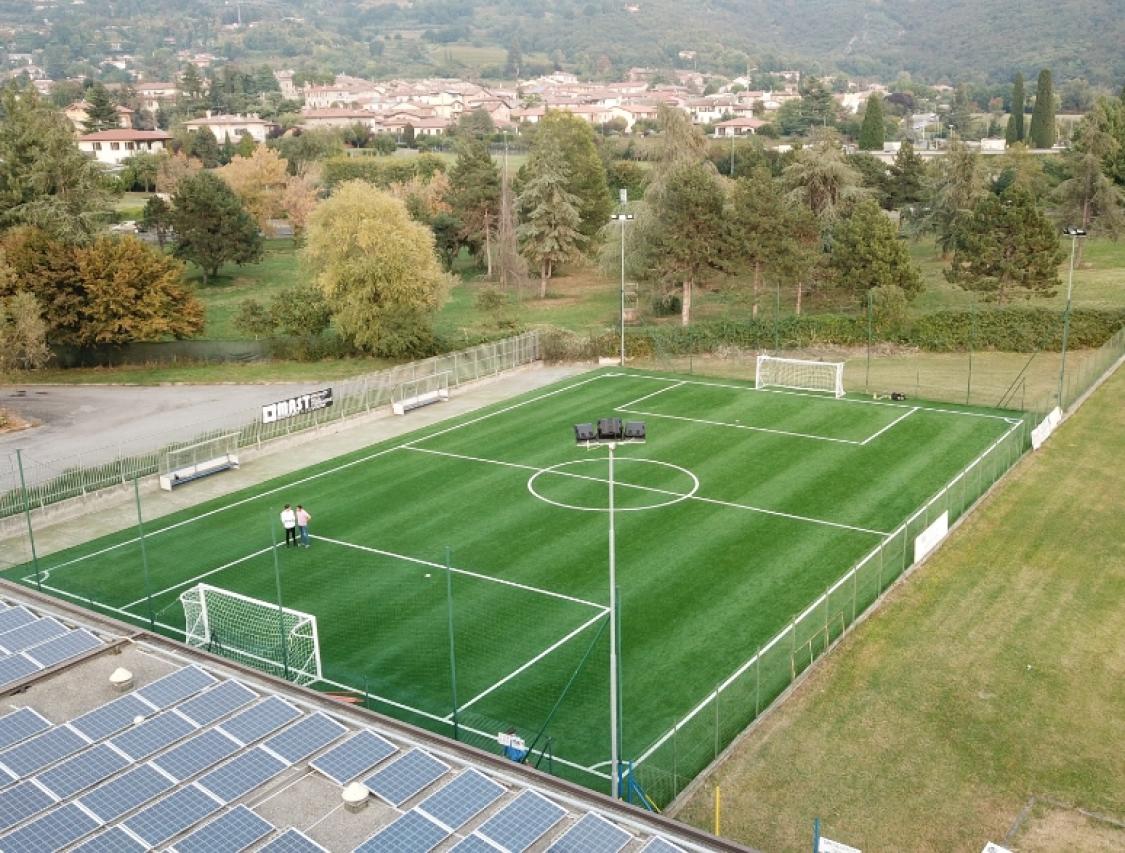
{"left": 180, "top": 583, "right": 321, "bottom": 684}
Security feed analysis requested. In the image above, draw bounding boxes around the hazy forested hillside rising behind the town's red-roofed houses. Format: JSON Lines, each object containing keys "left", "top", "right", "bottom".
{"left": 0, "top": 0, "right": 1125, "bottom": 88}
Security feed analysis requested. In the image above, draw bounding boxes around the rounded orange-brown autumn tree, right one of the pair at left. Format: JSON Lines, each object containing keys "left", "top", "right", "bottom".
{"left": 75, "top": 236, "right": 204, "bottom": 345}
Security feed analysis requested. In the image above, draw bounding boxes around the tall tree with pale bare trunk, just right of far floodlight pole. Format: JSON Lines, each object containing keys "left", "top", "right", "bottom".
{"left": 649, "top": 163, "right": 729, "bottom": 325}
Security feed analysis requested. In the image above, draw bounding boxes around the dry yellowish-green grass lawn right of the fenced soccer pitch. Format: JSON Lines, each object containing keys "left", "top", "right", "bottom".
{"left": 677, "top": 370, "right": 1125, "bottom": 851}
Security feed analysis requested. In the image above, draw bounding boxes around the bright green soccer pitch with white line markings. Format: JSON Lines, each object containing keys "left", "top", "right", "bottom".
{"left": 7, "top": 371, "right": 1026, "bottom": 801}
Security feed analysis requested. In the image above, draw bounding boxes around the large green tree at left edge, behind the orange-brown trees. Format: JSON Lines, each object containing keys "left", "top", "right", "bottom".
{"left": 0, "top": 82, "right": 110, "bottom": 242}
